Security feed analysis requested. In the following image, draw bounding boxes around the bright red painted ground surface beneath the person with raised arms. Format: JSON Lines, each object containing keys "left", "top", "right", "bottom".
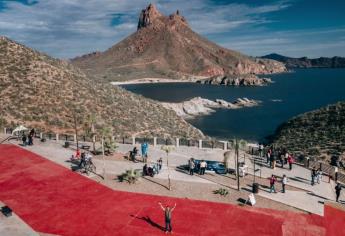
{"left": 0, "top": 145, "right": 340, "bottom": 236}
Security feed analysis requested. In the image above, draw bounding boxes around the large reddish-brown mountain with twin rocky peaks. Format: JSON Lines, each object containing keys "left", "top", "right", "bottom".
{"left": 72, "top": 4, "right": 286, "bottom": 81}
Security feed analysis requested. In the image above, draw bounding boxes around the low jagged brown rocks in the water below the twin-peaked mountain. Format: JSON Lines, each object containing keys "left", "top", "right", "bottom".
{"left": 196, "top": 75, "right": 272, "bottom": 86}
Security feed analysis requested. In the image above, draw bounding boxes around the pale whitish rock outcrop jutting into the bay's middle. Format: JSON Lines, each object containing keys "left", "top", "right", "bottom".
{"left": 162, "top": 97, "right": 260, "bottom": 118}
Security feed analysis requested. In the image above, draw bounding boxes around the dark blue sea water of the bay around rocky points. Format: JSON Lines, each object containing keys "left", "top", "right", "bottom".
{"left": 123, "top": 69, "right": 345, "bottom": 141}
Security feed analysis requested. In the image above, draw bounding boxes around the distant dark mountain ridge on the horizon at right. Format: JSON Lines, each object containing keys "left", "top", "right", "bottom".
{"left": 261, "top": 53, "right": 345, "bottom": 68}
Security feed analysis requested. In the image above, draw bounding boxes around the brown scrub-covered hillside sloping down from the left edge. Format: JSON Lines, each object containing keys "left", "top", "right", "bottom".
{"left": 0, "top": 37, "right": 202, "bottom": 137}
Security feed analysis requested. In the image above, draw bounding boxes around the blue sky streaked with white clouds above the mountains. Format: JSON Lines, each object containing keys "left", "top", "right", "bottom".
{"left": 0, "top": 0, "right": 345, "bottom": 58}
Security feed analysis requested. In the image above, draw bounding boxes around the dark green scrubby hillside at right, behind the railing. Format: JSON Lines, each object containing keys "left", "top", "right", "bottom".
{"left": 273, "top": 102, "right": 345, "bottom": 159}
